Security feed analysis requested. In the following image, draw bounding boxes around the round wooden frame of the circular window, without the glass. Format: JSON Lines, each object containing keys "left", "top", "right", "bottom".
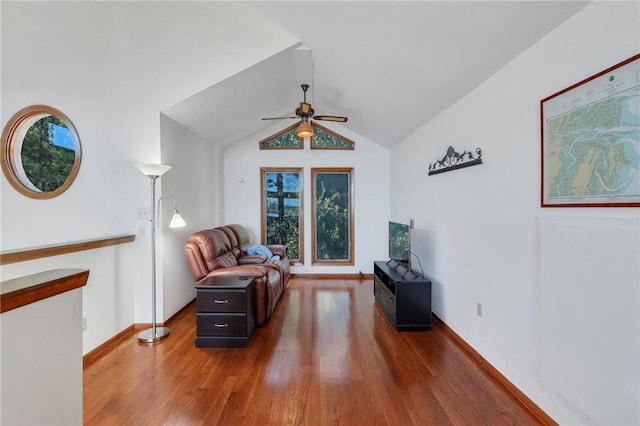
{"left": 0, "top": 105, "right": 82, "bottom": 199}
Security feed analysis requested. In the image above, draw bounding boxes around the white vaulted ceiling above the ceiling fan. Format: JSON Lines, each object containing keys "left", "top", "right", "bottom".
{"left": 163, "top": 1, "right": 588, "bottom": 147}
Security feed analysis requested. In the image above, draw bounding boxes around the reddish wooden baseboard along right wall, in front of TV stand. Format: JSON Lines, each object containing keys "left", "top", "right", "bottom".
{"left": 432, "top": 314, "right": 558, "bottom": 426}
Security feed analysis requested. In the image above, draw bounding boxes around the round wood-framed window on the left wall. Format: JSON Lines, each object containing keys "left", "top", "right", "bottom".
{"left": 1, "top": 105, "right": 82, "bottom": 198}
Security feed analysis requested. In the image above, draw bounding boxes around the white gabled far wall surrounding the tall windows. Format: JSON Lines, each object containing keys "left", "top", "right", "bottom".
{"left": 224, "top": 120, "right": 390, "bottom": 274}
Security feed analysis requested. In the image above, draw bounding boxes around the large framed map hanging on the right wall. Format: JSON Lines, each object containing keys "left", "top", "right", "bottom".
{"left": 540, "top": 54, "right": 640, "bottom": 207}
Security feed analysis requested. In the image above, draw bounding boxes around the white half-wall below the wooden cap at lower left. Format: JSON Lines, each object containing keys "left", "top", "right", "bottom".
{"left": 0, "top": 289, "right": 82, "bottom": 426}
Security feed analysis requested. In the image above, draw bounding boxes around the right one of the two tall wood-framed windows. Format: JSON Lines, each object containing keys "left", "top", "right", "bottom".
{"left": 311, "top": 168, "right": 354, "bottom": 265}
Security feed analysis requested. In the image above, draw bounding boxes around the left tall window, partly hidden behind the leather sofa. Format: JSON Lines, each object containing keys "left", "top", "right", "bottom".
{"left": 260, "top": 167, "right": 304, "bottom": 263}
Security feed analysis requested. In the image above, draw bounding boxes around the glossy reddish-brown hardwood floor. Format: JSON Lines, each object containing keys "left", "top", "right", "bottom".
{"left": 84, "top": 278, "right": 539, "bottom": 426}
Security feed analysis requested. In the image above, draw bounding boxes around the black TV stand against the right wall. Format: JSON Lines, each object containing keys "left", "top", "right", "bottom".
{"left": 373, "top": 261, "right": 431, "bottom": 331}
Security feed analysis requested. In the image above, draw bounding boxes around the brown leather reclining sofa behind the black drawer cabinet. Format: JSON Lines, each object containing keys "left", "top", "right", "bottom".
{"left": 184, "top": 224, "right": 291, "bottom": 325}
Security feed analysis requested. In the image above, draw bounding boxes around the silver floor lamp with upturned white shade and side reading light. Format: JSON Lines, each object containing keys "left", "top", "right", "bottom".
{"left": 136, "top": 163, "right": 185, "bottom": 343}
